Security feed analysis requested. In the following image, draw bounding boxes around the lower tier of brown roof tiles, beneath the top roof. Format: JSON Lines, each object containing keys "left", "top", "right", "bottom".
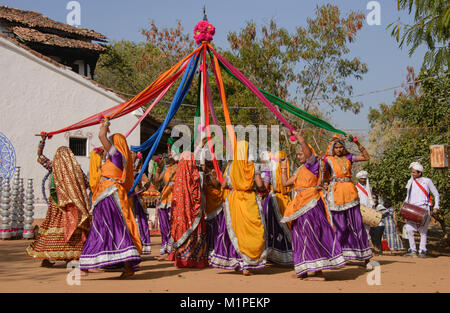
{"left": 9, "top": 26, "right": 106, "bottom": 52}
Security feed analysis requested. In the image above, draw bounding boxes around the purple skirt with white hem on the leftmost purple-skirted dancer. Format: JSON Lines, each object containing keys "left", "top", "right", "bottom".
{"left": 80, "top": 194, "right": 141, "bottom": 269}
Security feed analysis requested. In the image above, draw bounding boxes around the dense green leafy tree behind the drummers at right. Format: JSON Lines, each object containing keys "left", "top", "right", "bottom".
{"left": 365, "top": 72, "right": 450, "bottom": 234}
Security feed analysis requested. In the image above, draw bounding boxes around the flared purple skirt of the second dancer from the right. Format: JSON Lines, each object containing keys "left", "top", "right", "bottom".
{"left": 291, "top": 199, "right": 345, "bottom": 276}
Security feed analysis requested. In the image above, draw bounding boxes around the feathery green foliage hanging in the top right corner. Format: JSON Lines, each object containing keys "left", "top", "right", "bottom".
{"left": 388, "top": 0, "right": 450, "bottom": 73}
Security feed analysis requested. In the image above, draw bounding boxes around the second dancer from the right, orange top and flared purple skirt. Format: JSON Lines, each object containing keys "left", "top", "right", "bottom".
{"left": 281, "top": 131, "right": 346, "bottom": 280}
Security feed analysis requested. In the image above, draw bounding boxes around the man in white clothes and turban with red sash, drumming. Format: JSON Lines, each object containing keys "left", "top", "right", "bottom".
{"left": 404, "top": 162, "right": 439, "bottom": 258}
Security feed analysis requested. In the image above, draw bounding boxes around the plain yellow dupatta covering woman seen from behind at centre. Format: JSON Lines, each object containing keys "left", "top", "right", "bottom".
{"left": 227, "top": 141, "right": 265, "bottom": 259}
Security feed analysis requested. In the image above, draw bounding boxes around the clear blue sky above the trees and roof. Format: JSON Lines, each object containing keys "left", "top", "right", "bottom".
{"left": 0, "top": 0, "right": 426, "bottom": 133}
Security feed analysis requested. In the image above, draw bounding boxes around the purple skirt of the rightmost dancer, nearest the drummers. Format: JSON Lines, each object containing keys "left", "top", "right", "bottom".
{"left": 331, "top": 204, "right": 372, "bottom": 261}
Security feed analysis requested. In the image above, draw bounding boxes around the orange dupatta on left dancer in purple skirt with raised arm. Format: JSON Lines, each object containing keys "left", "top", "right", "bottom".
{"left": 92, "top": 134, "right": 142, "bottom": 254}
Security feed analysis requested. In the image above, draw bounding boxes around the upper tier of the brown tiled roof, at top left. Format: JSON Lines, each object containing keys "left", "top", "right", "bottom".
{"left": 0, "top": 6, "right": 106, "bottom": 41}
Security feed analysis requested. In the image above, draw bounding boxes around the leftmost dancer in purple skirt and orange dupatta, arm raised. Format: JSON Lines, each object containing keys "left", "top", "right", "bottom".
{"left": 80, "top": 119, "right": 142, "bottom": 278}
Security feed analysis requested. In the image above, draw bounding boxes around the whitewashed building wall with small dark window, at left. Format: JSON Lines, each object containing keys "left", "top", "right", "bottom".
{"left": 0, "top": 38, "right": 140, "bottom": 218}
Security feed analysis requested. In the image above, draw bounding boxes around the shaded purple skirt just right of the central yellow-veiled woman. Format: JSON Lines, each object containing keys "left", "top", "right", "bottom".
{"left": 263, "top": 194, "right": 292, "bottom": 265}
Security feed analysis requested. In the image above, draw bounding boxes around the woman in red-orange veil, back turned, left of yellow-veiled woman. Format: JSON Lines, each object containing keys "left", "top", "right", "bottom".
{"left": 169, "top": 151, "right": 208, "bottom": 268}
